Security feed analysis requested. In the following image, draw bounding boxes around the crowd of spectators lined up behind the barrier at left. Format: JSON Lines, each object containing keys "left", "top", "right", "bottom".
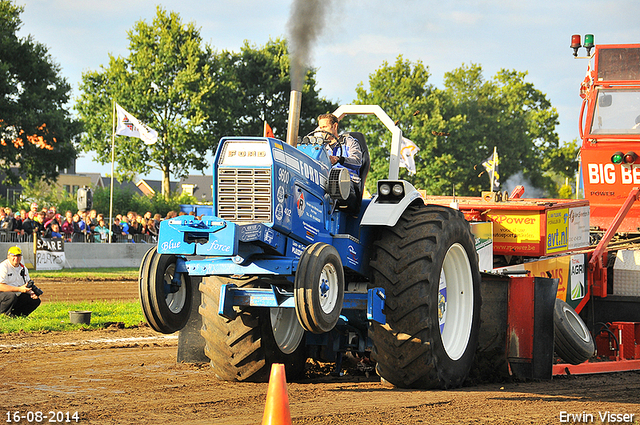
{"left": 0, "top": 202, "right": 185, "bottom": 243}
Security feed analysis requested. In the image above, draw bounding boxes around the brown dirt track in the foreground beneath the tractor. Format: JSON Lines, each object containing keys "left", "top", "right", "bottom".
{"left": 0, "top": 282, "right": 640, "bottom": 425}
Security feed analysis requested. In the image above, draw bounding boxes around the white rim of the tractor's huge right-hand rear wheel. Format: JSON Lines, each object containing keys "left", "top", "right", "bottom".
{"left": 438, "top": 243, "right": 474, "bottom": 360}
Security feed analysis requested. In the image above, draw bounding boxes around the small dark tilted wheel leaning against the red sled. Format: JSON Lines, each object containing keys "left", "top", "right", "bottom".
{"left": 553, "top": 298, "right": 595, "bottom": 365}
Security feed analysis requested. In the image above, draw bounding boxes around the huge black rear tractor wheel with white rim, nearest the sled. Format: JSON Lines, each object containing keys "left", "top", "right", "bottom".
{"left": 370, "top": 205, "right": 481, "bottom": 389}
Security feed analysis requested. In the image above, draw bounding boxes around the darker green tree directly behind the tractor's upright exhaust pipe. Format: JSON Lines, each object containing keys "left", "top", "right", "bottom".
{"left": 220, "top": 39, "right": 337, "bottom": 140}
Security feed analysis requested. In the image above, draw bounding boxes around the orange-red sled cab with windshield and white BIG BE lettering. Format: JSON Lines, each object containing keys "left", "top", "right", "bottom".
{"left": 580, "top": 44, "right": 640, "bottom": 233}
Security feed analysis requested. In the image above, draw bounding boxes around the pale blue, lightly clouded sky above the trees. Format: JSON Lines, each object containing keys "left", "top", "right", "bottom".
{"left": 14, "top": 0, "right": 640, "bottom": 180}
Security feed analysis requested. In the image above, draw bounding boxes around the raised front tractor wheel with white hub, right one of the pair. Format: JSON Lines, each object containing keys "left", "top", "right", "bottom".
{"left": 294, "top": 242, "right": 344, "bottom": 334}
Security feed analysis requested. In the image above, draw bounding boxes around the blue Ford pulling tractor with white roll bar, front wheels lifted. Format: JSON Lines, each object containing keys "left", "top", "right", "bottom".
{"left": 139, "top": 105, "right": 481, "bottom": 388}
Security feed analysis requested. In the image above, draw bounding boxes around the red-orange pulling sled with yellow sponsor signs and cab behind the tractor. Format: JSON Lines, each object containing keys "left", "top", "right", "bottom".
{"left": 424, "top": 36, "right": 640, "bottom": 375}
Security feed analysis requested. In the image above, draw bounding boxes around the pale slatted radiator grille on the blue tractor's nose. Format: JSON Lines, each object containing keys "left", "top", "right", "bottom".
{"left": 217, "top": 168, "right": 273, "bottom": 223}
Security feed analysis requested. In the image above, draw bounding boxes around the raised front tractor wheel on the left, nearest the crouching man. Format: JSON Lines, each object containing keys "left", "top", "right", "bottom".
{"left": 138, "top": 247, "right": 192, "bottom": 334}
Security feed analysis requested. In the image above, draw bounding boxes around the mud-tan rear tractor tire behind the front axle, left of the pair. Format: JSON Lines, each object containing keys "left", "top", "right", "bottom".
{"left": 199, "top": 276, "right": 307, "bottom": 382}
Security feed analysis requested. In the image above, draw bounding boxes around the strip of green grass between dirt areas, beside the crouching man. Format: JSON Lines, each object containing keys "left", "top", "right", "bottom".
{"left": 0, "top": 301, "right": 145, "bottom": 333}
